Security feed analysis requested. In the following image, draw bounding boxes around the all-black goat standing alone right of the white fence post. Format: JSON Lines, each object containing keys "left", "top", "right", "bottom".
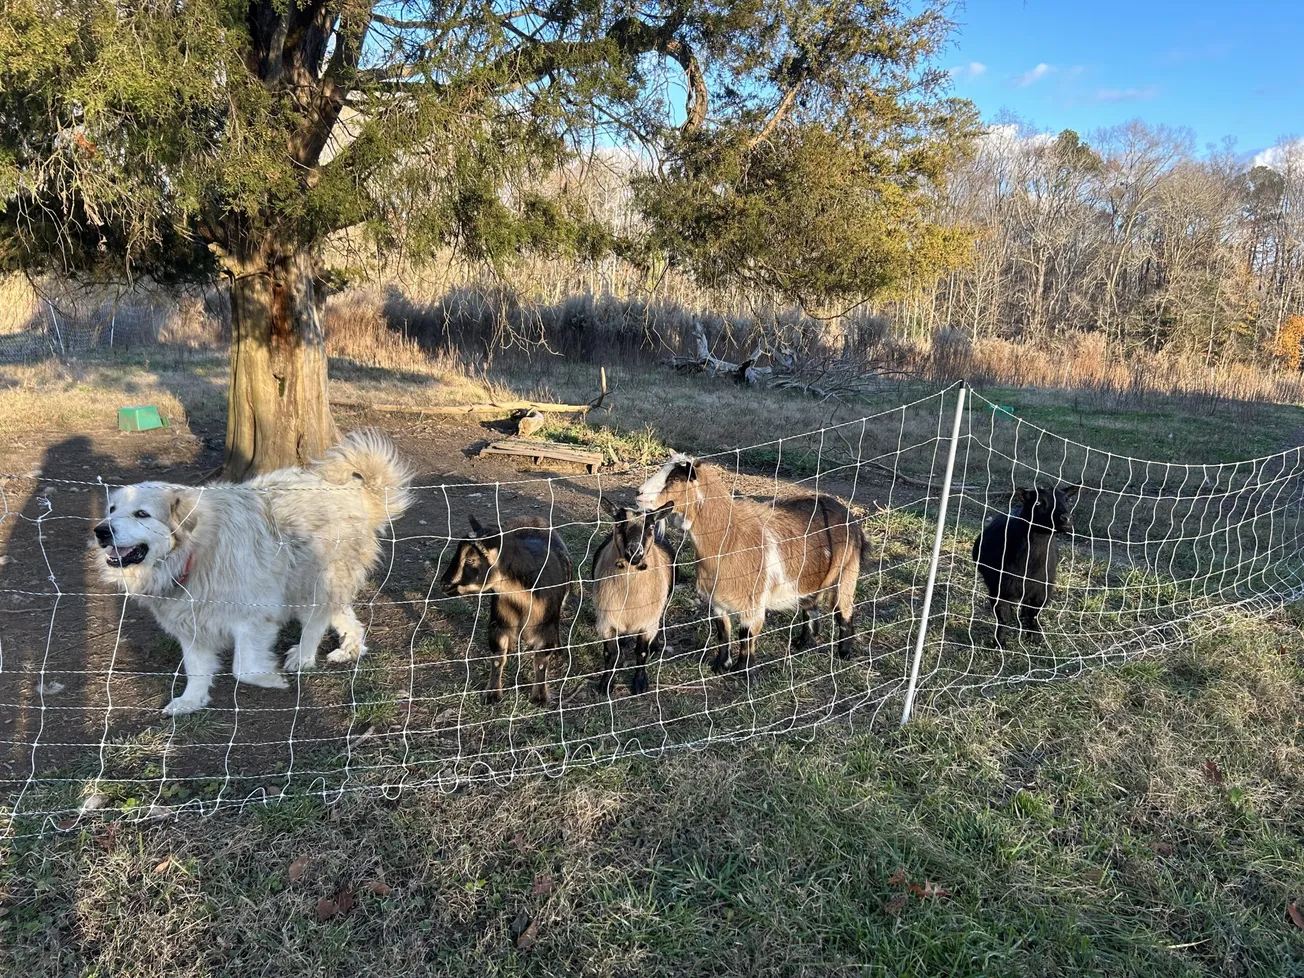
{"left": 973, "top": 485, "right": 1081, "bottom": 648}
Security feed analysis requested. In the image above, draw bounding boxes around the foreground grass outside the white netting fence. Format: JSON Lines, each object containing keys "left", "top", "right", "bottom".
{"left": 0, "top": 623, "right": 1304, "bottom": 975}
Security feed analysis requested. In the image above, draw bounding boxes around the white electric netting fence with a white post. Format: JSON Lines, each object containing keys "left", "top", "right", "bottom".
{"left": 0, "top": 386, "right": 1304, "bottom": 836}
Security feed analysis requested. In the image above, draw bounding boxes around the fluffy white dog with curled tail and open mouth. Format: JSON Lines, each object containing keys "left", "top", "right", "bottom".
{"left": 95, "top": 430, "right": 411, "bottom": 716}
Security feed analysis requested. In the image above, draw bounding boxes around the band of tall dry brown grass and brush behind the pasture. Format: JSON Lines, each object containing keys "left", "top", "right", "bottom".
{"left": 10, "top": 262, "right": 1304, "bottom": 426}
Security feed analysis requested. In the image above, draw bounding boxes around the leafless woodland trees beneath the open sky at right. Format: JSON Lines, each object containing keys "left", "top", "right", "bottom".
{"left": 893, "top": 121, "right": 1304, "bottom": 369}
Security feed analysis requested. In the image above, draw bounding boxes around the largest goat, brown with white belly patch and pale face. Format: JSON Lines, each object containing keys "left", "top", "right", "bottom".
{"left": 639, "top": 455, "right": 863, "bottom": 672}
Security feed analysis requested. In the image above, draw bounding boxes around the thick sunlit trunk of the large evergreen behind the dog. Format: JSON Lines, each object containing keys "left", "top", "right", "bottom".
{"left": 222, "top": 248, "right": 338, "bottom": 481}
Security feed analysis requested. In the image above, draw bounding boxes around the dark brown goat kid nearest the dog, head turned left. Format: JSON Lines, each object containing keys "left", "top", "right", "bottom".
{"left": 443, "top": 516, "right": 571, "bottom": 703}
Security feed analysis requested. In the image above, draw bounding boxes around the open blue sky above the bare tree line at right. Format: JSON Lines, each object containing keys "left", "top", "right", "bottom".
{"left": 944, "top": 0, "right": 1304, "bottom": 156}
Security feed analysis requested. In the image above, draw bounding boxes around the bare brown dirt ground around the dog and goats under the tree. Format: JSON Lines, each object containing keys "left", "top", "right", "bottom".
{"left": 0, "top": 413, "right": 918, "bottom": 811}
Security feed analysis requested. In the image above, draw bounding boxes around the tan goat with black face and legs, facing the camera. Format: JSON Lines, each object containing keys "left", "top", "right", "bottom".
{"left": 593, "top": 497, "right": 674, "bottom": 694}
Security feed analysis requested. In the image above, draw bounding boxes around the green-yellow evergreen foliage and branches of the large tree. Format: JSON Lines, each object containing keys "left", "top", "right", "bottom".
{"left": 0, "top": 0, "right": 974, "bottom": 301}
